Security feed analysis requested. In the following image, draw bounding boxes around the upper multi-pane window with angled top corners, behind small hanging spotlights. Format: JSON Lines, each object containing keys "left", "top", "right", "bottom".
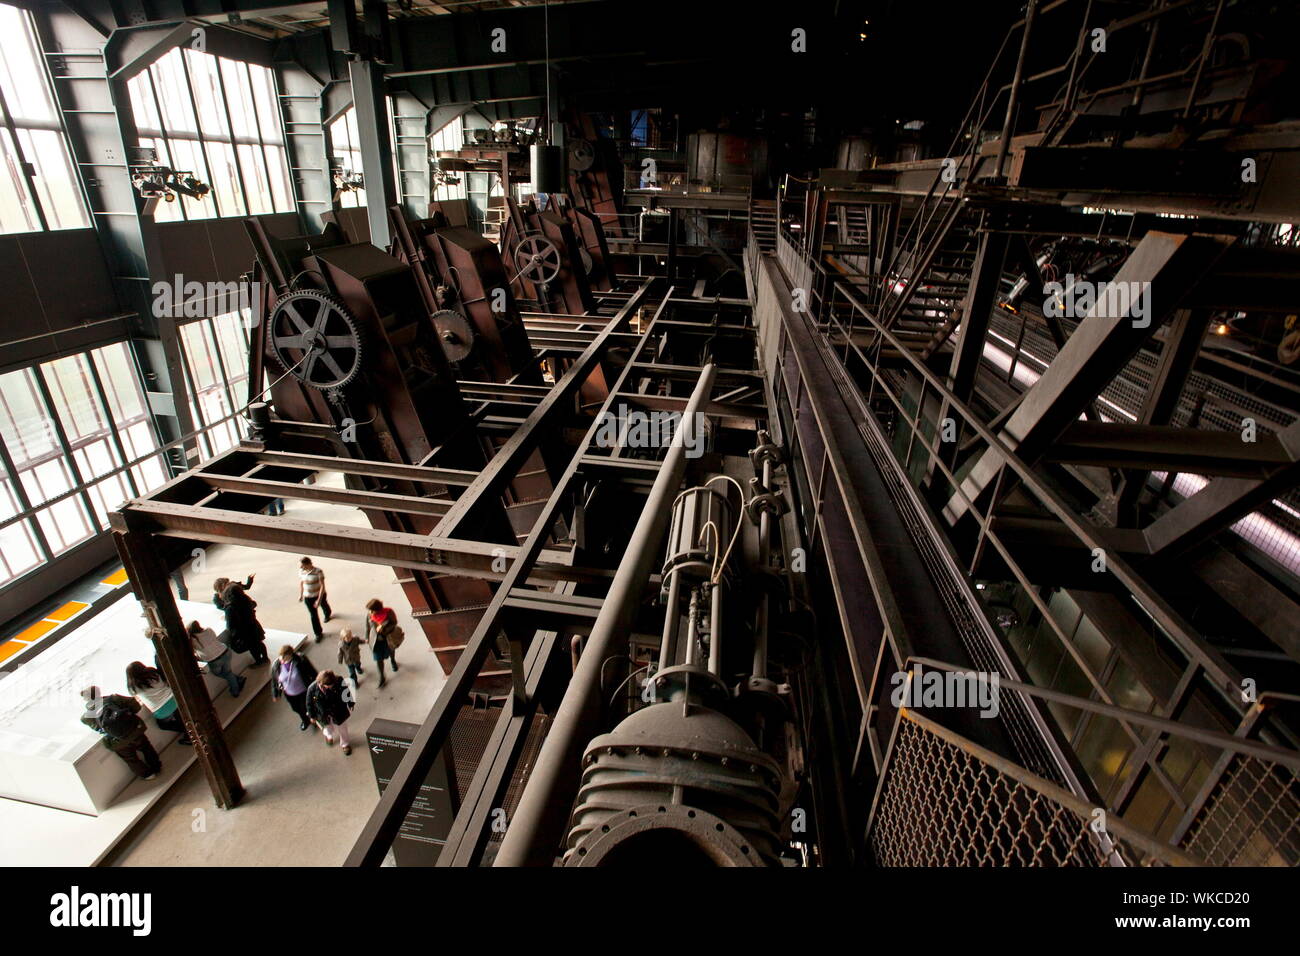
{"left": 127, "top": 47, "right": 294, "bottom": 222}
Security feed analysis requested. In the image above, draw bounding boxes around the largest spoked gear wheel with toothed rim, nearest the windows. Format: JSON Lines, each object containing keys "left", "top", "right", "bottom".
{"left": 268, "top": 289, "right": 361, "bottom": 389}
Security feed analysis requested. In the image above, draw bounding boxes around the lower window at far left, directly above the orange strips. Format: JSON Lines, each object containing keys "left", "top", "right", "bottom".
{"left": 0, "top": 342, "right": 166, "bottom": 584}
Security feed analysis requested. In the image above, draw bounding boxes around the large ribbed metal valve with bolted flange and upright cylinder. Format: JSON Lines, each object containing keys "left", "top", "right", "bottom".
{"left": 564, "top": 442, "right": 790, "bottom": 866}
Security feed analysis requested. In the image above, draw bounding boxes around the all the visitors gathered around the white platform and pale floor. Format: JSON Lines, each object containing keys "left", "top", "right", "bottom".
{"left": 82, "top": 558, "right": 404, "bottom": 780}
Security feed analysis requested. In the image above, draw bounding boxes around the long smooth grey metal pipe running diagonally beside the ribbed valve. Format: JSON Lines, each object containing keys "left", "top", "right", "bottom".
{"left": 494, "top": 364, "right": 718, "bottom": 866}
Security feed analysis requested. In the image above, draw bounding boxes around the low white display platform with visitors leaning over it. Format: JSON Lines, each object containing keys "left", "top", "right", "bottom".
{"left": 0, "top": 594, "right": 297, "bottom": 816}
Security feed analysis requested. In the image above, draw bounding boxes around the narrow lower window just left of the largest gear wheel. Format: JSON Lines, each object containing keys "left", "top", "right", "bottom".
{"left": 181, "top": 310, "right": 251, "bottom": 458}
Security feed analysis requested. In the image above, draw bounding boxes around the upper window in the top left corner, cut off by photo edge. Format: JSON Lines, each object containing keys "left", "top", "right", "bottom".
{"left": 0, "top": 4, "right": 90, "bottom": 233}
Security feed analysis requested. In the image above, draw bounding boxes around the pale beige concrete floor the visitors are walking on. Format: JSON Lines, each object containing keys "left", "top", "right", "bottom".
{"left": 105, "top": 481, "right": 443, "bottom": 866}
